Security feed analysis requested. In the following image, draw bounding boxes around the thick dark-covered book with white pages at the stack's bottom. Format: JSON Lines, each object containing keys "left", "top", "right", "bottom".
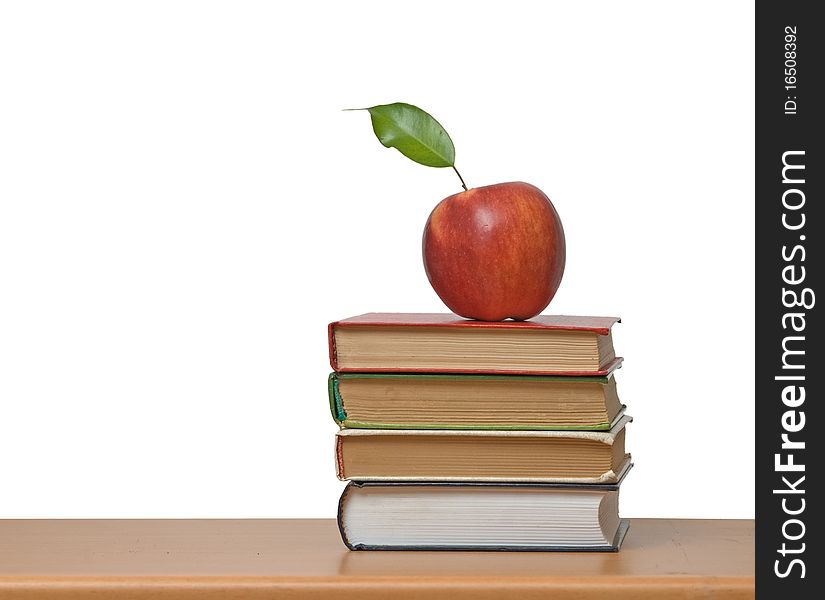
{"left": 337, "top": 472, "right": 632, "bottom": 552}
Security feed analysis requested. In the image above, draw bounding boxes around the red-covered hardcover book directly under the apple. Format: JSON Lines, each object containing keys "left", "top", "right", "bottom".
{"left": 329, "top": 313, "right": 622, "bottom": 376}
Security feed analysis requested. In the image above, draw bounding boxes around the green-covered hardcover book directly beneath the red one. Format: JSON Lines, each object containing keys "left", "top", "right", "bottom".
{"left": 329, "top": 372, "right": 624, "bottom": 431}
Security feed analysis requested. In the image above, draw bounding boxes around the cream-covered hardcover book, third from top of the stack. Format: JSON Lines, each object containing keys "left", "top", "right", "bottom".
{"left": 335, "top": 416, "right": 631, "bottom": 483}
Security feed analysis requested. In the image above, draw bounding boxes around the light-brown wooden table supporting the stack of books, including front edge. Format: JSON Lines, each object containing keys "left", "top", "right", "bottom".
{"left": 0, "top": 519, "right": 754, "bottom": 600}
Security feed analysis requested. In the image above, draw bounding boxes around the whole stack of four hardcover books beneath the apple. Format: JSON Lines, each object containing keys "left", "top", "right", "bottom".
{"left": 329, "top": 313, "right": 631, "bottom": 551}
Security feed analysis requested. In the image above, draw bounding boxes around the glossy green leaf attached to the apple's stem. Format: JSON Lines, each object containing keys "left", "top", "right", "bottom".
{"left": 366, "top": 102, "right": 455, "bottom": 167}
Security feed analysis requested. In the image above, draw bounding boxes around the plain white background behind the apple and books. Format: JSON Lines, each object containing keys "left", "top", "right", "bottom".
{"left": 0, "top": 1, "right": 754, "bottom": 518}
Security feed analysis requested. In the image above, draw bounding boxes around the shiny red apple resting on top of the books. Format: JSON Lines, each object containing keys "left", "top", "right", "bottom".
{"left": 422, "top": 182, "right": 565, "bottom": 321}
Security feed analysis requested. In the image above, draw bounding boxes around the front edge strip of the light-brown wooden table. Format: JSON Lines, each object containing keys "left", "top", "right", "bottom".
{"left": 0, "top": 575, "right": 755, "bottom": 600}
